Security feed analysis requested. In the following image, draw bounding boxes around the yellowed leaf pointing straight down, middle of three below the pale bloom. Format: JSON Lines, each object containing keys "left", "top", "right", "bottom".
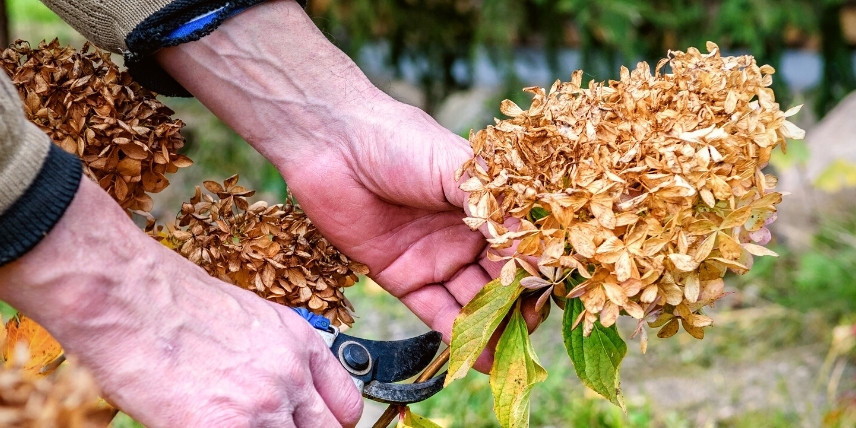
{"left": 490, "top": 305, "right": 547, "bottom": 427}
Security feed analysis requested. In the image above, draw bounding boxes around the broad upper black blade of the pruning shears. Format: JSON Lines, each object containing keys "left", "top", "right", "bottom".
{"left": 330, "top": 331, "right": 443, "bottom": 383}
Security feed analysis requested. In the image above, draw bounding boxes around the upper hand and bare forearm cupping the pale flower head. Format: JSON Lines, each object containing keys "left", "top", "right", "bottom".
{"left": 159, "top": 1, "right": 538, "bottom": 371}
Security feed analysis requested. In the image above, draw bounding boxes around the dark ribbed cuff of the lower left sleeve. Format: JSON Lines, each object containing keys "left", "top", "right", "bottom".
{"left": 0, "top": 144, "right": 83, "bottom": 266}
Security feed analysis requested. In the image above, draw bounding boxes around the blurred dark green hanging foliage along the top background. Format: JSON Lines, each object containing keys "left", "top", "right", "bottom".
{"left": 310, "top": 0, "right": 856, "bottom": 115}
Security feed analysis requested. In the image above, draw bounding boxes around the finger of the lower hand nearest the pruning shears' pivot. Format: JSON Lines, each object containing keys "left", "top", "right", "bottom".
{"left": 306, "top": 328, "right": 363, "bottom": 426}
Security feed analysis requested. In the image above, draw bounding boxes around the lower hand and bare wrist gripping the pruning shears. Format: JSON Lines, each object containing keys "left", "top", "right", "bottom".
{"left": 0, "top": 179, "right": 362, "bottom": 426}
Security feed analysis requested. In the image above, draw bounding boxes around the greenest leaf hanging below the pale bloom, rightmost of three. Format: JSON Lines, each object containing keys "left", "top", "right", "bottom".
{"left": 562, "top": 298, "right": 627, "bottom": 412}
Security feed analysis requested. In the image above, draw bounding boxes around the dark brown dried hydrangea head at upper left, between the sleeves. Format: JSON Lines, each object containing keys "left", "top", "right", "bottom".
{"left": 0, "top": 40, "right": 192, "bottom": 211}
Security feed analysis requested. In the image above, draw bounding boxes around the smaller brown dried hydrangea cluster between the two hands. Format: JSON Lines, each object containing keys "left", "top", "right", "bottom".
{"left": 150, "top": 175, "right": 368, "bottom": 326}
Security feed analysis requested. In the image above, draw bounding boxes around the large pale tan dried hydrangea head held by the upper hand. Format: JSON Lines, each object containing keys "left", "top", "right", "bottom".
{"left": 458, "top": 43, "right": 804, "bottom": 349}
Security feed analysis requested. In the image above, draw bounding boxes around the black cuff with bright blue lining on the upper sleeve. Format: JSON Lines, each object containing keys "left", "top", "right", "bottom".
{"left": 125, "top": 0, "right": 306, "bottom": 97}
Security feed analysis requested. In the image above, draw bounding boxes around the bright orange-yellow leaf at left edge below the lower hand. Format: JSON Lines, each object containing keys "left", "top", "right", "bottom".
{"left": 3, "top": 315, "right": 62, "bottom": 376}
